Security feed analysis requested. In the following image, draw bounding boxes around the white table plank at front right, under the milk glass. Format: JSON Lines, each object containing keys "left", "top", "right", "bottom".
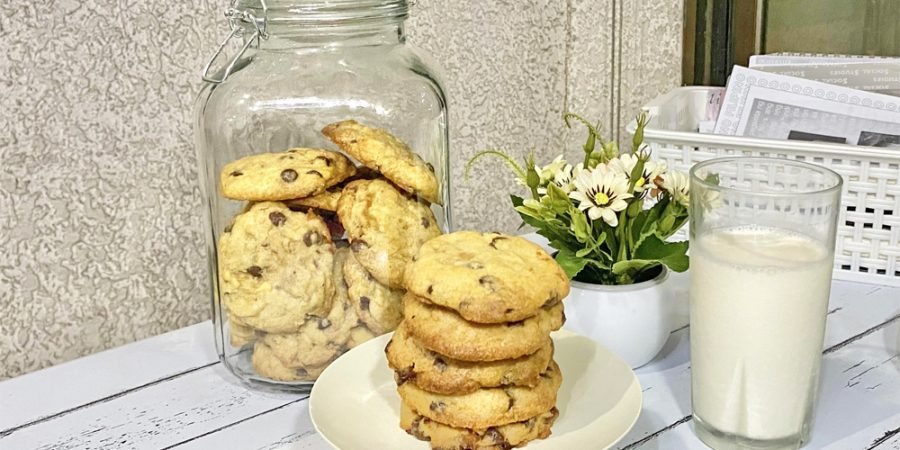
{"left": 633, "top": 316, "right": 900, "bottom": 450}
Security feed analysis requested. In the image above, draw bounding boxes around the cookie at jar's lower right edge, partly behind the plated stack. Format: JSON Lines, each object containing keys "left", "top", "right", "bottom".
{"left": 344, "top": 255, "right": 404, "bottom": 334}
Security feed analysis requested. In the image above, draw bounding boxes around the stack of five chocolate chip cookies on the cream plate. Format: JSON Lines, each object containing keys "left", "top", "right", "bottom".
{"left": 385, "top": 231, "right": 569, "bottom": 450}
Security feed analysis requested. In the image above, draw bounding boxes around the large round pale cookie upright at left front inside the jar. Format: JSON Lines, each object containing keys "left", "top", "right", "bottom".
{"left": 218, "top": 202, "right": 334, "bottom": 333}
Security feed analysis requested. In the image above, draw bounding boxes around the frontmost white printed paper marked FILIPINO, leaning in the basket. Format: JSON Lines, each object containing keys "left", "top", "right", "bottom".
{"left": 714, "top": 66, "right": 900, "bottom": 147}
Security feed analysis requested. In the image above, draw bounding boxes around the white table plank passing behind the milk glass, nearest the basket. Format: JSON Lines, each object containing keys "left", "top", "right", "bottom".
{"left": 619, "top": 281, "right": 900, "bottom": 449}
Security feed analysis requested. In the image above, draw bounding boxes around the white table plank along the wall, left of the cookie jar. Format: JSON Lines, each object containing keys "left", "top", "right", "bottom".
{"left": 0, "top": 322, "right": 218, "bottom": 435}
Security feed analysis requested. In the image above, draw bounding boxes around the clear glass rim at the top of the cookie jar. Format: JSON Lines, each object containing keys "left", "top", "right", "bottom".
{"left": 234, "top": 0, "right": 410, "bottom": 25}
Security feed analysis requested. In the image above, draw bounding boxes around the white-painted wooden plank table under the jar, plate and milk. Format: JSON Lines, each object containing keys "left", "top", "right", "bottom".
{"left": 0, "top": 278, "right": 900, "bottom": 450}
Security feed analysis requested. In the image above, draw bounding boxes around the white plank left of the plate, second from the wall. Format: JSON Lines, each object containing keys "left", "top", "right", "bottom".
{"left": 0, "top": 364, "right": 305, "bottom": 450}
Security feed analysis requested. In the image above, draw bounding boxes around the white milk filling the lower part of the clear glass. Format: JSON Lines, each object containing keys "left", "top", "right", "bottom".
{"left": 690, "top": 228, "right": 833, "bottom": 440}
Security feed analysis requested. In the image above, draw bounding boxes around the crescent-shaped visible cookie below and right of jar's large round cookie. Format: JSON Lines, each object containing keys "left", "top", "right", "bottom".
{"left": 262, "top": 248, "right": 359, "bottom": 367}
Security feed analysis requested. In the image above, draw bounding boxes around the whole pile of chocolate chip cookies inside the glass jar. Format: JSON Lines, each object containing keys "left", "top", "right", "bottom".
{"left": 218, "top": 121, "right": 441, "bottom": 381}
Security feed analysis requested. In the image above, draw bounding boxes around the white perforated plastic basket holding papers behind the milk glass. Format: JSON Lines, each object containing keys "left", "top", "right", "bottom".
{"left": 627, "top": 87, "right": 900, "bottom": 286}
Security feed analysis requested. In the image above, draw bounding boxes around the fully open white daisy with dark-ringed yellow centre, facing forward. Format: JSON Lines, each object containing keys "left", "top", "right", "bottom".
{"left": 569, "top": 164, "right": 632, "bottom": 227}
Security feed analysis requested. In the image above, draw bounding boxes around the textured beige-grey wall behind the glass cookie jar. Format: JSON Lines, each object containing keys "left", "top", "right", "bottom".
{"left": 0, "top": 0, "right": 681, "bottom": 379}
